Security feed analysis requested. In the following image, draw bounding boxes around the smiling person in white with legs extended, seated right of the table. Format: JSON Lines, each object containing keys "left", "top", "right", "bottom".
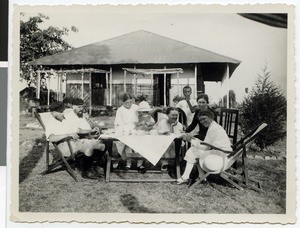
{"left": 177, "top": 110, "right": 232, "bottom": 184}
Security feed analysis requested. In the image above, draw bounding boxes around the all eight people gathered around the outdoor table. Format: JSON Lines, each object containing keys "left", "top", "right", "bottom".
{"left": 46, "top": 86, "right": 232, "bottom": 184}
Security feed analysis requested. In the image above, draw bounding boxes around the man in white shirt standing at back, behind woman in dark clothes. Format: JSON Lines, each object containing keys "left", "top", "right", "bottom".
{"left": 176, "top": 85, "right": 197, "bottom": 126}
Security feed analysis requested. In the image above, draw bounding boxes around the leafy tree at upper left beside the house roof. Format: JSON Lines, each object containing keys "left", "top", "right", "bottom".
{"left": 20, "top": 14, "right": 78, "bottom": 85}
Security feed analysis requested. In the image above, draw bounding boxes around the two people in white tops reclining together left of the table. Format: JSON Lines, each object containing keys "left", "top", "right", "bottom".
{"left": 45, "top": 101, "right": 105, "bottom": 179}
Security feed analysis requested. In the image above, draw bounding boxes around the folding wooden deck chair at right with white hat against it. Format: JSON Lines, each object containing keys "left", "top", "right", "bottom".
{"left": 189, "top": 123, "right": 267, "bottom": 191}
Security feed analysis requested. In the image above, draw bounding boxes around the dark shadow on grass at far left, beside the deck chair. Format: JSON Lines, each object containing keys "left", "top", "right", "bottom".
{"left": 19, "top": 138, "right": 45, "bottom": 183}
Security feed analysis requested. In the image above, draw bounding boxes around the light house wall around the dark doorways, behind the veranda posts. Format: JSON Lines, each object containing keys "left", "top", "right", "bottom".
{"left": 66, "top": 64, "right": 197, "bottom": 106}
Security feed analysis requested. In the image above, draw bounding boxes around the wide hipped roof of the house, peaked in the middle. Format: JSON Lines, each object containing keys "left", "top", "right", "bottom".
{"left": 30, "top": 30, "right": 240, "bottom": 69}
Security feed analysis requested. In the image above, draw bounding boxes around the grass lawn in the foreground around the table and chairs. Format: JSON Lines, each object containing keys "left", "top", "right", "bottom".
{"left": 19, "top": 116, "right": 286, "bottom": 214}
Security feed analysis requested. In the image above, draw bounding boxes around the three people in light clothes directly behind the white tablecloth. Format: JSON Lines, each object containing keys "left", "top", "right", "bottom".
{"left": 113, "top": 93, "right": 183, "bottom": 173}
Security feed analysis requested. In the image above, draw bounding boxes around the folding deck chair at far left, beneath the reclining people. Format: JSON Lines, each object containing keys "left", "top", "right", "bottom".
{"left": 34, "top": 111, "right": 78, "bottom": 182}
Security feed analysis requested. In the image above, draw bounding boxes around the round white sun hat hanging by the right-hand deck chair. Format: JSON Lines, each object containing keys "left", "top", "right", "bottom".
{"left": 199, "top": 150, "right": 228, "bottom": 174}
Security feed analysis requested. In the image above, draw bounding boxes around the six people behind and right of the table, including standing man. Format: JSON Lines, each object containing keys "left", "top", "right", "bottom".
{"left": 111, "top": 86, "right": 232, "bottom": 184}
